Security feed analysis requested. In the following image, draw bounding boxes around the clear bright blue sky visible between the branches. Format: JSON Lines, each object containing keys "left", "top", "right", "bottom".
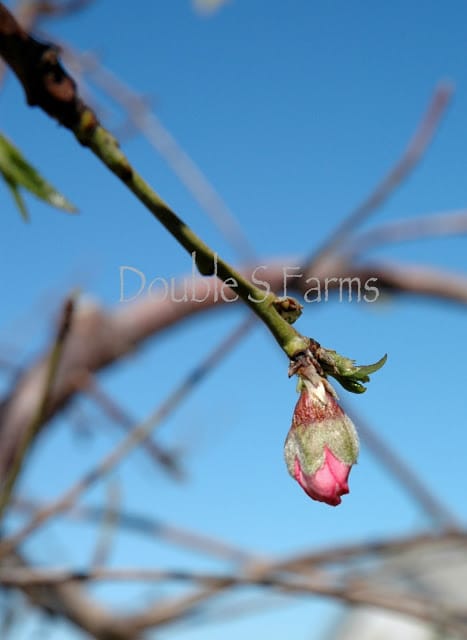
{"left": 0, "top": 0, "right": 467, "bottom": 640}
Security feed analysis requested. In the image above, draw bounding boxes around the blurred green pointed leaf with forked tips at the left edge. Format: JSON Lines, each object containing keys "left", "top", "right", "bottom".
{"left": 0, "top": 134, "right": 76, "bottom": 220}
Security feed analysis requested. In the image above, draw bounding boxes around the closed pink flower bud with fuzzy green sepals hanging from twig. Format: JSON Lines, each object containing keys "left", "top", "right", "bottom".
{"left": 285, "top": 365, "right": 359, "bottom": 506}
